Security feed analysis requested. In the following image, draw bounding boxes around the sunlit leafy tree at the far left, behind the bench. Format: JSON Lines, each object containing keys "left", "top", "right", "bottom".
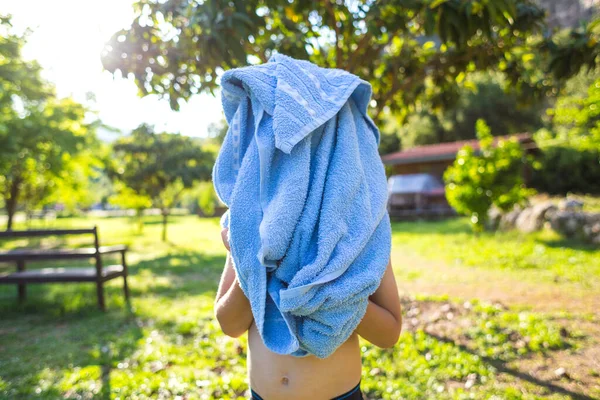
{"left": 0, "top": 96, "right": 95, "bottom": 230}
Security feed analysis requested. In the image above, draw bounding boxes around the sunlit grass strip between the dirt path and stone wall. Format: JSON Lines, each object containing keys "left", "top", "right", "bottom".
{"left": 393, "top": 218, "right": 600, "bottom": 288}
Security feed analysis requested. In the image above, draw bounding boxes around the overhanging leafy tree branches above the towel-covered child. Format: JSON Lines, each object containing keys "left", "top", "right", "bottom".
{"left": 102, "top": 0, "right": 600, "bottom": 121}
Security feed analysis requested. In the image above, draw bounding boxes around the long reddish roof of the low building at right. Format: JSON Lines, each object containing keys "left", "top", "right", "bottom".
{"left": 381, "top": 133, "right": 535, "bottom": 164}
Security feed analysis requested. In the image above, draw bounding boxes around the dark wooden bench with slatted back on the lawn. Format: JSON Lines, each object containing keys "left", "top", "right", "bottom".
{"left": 0, "top": 227, "right": 129, "bottom": 311}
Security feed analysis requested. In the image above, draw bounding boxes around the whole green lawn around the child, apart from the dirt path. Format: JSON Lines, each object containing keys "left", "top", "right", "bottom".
{"left": 0, "top": 216, "right": 600, "bottom": 399}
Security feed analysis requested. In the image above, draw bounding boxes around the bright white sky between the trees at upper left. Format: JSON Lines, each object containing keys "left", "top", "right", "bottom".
{"left": 0, "top": 0, "right": 223, "bottom": 138}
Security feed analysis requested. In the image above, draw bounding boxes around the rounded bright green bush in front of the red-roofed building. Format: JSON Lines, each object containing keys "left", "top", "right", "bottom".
{"left": 444, "top": 120, "right": 532, "bottom": 231}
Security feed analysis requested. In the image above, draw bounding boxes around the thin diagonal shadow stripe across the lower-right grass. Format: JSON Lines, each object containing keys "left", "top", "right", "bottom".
{"left": 425, "top": 332, "right": 594, "bottom": 400}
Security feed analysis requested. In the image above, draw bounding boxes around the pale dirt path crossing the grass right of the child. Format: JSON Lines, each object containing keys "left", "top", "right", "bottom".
{"left": 392, "top": 252, "right": 600, "bottom": 315}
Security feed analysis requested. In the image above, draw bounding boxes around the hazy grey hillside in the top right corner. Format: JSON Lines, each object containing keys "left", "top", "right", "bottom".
{"left": 535, "top": 0, "right": 600, "bottom": 28}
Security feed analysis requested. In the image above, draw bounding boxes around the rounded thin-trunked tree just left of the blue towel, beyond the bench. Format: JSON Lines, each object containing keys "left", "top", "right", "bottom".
{"left": 109, "top": 124, "right": 214, "bottom": 241}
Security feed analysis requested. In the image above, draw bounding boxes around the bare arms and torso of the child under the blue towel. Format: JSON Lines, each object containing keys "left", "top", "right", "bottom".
{"left": 215, "top": 229, "right": 402, "bottom": 400}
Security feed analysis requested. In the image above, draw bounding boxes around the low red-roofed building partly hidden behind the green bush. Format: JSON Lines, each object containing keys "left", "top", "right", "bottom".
{"left": 381, "top": 133, "right": 537, "bottom": 179}
